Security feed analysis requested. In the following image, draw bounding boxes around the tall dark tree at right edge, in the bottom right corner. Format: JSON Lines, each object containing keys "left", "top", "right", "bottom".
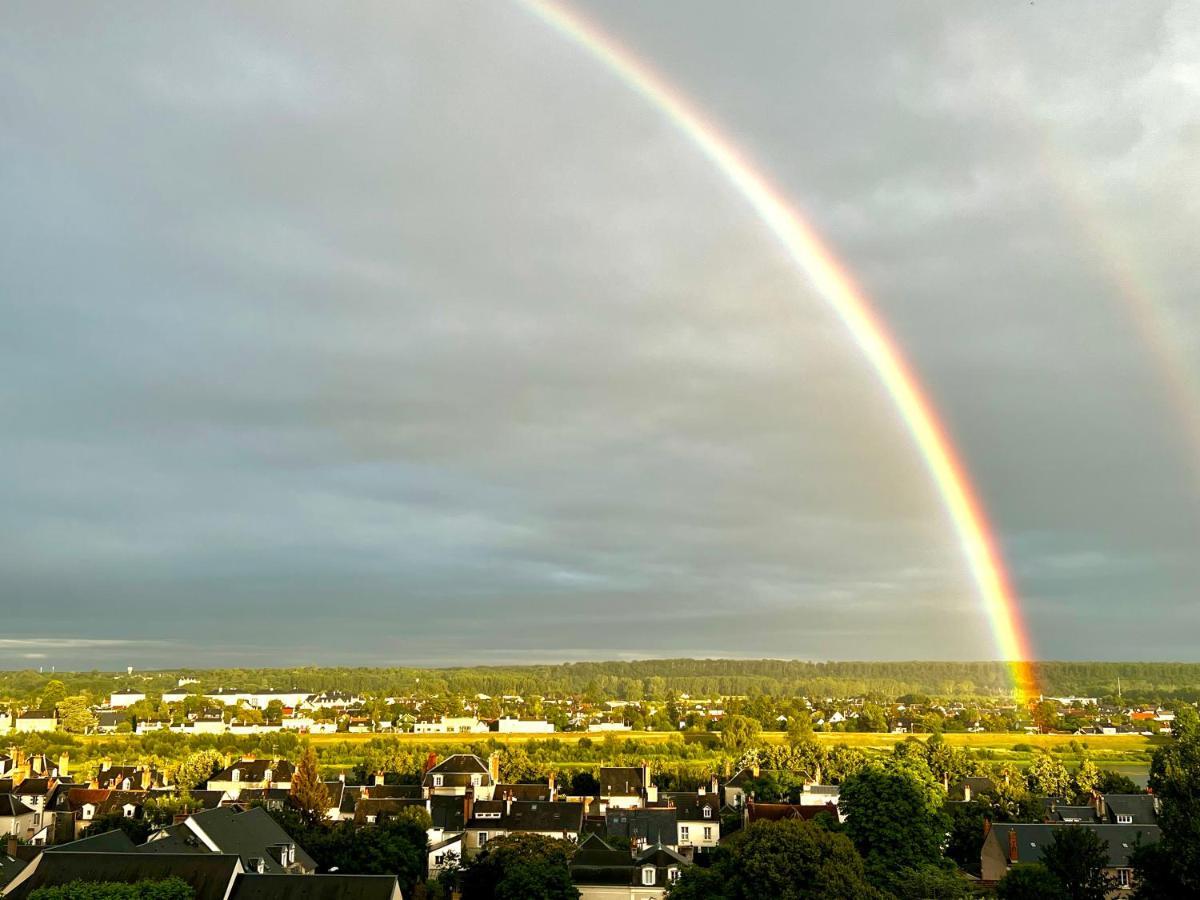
{"left": 1133, "top": 707, "right": 1200, "bottom": 898}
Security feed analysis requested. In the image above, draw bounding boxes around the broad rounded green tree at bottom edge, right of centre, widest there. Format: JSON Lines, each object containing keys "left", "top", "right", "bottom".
{"left": 668, "top": 820, "right": 882, "bottom": 900}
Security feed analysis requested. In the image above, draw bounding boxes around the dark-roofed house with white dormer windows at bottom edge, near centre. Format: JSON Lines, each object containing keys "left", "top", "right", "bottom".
{"left": 571, "top": 834, "right": 691, "bottom": 900}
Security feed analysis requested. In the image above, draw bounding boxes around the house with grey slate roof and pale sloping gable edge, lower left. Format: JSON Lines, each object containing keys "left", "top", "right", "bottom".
{"left": 134, "top": 806, "right": 317, "bottom": 875}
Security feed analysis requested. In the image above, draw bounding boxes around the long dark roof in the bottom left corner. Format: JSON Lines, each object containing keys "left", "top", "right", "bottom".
{"left": 5, "top": 852, "right": 238, "bottom": 900}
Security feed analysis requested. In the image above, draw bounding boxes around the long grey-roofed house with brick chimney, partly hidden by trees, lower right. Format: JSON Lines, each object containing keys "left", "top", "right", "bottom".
{"left": 979, "top": 822, "right": 1158, "bottom": 896}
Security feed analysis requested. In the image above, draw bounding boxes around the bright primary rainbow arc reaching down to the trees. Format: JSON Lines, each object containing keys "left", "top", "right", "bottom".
{"left": 518, "top": 0, "right": 1036, "bottom": 697}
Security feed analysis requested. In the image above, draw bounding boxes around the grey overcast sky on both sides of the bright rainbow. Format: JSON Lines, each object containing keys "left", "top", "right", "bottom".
{"left": 0, "top": 0, "right": 1200, "bottom": 667}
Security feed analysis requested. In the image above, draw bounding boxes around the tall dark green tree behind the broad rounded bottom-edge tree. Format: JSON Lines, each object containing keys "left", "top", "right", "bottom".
{"left": 839, "top": 767, "right": 948, "bottom": 894}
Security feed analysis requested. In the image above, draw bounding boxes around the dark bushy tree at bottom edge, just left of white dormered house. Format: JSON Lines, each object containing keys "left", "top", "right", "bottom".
{"left": 460, "top": 834, "right": 580, "bottom": 900}
